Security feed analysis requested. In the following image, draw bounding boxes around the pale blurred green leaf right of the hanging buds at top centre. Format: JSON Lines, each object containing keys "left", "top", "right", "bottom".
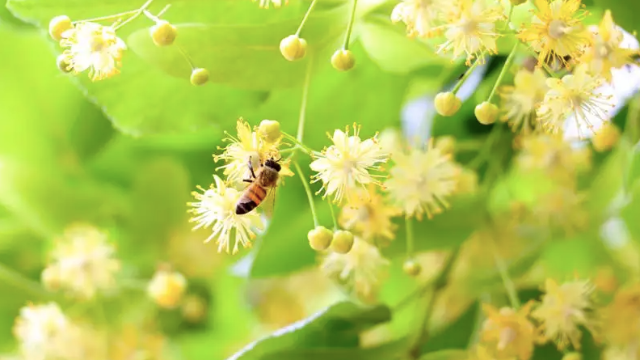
{"left": 355, "top": 16, "right": 451, "bottom": 74}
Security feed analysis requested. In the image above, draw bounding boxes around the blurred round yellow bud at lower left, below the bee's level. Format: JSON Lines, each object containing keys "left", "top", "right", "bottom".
{"left": 147, "top": 270, "right": 187, "bottom": 309}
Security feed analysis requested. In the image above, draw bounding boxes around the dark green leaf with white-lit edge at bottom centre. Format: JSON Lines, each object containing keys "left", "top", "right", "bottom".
{"left": 229, "top": 302, "right": 391, "bottom": 360}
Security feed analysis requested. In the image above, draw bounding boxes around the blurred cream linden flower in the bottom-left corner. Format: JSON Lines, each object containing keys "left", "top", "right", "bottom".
{"left": 13, "top": 303, "right": 71, "bottom": 360}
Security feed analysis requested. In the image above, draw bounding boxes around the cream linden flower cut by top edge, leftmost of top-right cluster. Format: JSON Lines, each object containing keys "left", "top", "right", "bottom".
{"left": 391, "top": 0, "right": 448, "bottom": 37}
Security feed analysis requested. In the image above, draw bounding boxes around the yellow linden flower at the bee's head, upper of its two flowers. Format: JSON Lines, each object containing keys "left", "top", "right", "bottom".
{"left": 213, "top": 119, "right": 293, "bottom": 184}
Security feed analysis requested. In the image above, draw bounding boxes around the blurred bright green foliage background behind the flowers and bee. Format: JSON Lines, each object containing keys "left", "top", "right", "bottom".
{"left": 0, "top": 0, "right": 640, "bottom": 360}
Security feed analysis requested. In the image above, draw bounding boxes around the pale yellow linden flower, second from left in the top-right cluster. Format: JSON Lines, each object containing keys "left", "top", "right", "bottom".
{"left": 438, "top": 0, "right": 504, "bottom": 65}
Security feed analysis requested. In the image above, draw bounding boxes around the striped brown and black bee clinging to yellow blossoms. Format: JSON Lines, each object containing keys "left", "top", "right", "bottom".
{"left": 236, "top": 159, "right": 281, "bottom": 215}
